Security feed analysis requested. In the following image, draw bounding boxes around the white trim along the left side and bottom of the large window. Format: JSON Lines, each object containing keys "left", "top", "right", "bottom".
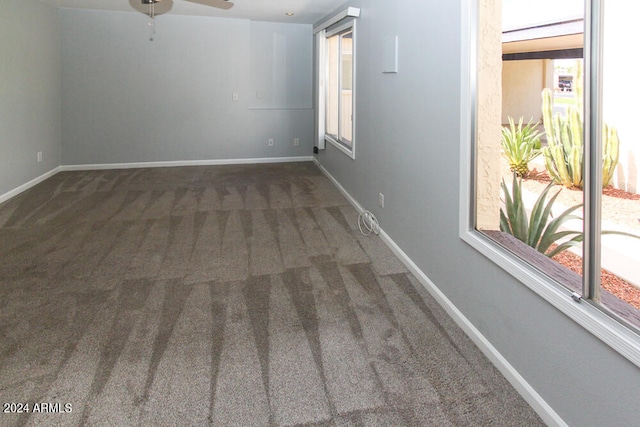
{"left": 459, "top": 0, "right": 640, "bottom": 367}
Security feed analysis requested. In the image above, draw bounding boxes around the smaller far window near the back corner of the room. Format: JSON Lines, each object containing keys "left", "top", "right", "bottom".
{"left": 323, "top": 21, "right": 355, "bottom": 157}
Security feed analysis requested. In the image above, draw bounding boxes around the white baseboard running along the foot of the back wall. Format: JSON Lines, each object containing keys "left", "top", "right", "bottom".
{"left": 60, "top": 156, "right": 313, "bottom": 171}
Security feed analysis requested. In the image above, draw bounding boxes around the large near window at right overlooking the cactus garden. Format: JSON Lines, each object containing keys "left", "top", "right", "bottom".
{"left": 460, "top": 0, "right": 640, "bottom": 366}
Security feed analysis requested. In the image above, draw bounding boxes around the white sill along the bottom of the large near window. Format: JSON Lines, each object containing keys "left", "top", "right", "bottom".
{"left": 461, "top": 230, "right": 640, "bottom": 368}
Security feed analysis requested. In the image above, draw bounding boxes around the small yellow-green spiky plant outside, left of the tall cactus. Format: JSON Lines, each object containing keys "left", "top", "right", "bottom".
{"left": 501, "top": 116, "right": 541, "bottom": 178}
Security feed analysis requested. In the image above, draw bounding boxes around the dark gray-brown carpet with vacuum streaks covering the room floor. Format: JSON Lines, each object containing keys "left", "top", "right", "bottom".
{"left": 0, "top": 163, "right": 542, "bottom": 426}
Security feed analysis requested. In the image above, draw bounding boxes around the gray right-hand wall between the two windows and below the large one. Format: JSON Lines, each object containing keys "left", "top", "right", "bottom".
{"left": 317, "top": 0, "right": 640, "bottom": 426}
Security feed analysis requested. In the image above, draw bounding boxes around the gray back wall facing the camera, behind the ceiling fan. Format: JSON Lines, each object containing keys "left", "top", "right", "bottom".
{"left": 60, "top": 9, "right": 313, "bottom": 165}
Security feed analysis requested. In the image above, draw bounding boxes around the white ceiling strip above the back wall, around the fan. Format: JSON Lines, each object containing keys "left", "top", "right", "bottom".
{"left": 40, "top": 0, "right": 345, "bottom": 24}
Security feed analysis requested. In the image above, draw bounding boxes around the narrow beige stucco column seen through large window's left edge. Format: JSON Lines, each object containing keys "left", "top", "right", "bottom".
{"left": 476, "top": 0, "right": 502, "bottom": 230}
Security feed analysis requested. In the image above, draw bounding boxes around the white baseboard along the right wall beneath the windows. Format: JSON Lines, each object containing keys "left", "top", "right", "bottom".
{"left": 314, "top": 159, "right": 567, "bottom": 427}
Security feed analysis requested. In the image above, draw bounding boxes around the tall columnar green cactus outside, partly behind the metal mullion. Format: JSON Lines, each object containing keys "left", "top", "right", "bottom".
{"left": 542, "top": 63, "right": 620, "bottom": 188}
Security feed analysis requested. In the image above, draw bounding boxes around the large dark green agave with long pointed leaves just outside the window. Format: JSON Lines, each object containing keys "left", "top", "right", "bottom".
{"left": 500, "top": 174, "right": 640, "bottom": 258}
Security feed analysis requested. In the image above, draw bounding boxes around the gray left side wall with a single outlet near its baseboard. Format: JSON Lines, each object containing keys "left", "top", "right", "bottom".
{"left": 0, "top": 0, "right": 60, "bottom": 196}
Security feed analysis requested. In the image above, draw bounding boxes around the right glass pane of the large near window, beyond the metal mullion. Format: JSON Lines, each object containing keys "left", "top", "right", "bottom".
{"left": 600, "top": 0, "right": 640, "bottom": 316}
